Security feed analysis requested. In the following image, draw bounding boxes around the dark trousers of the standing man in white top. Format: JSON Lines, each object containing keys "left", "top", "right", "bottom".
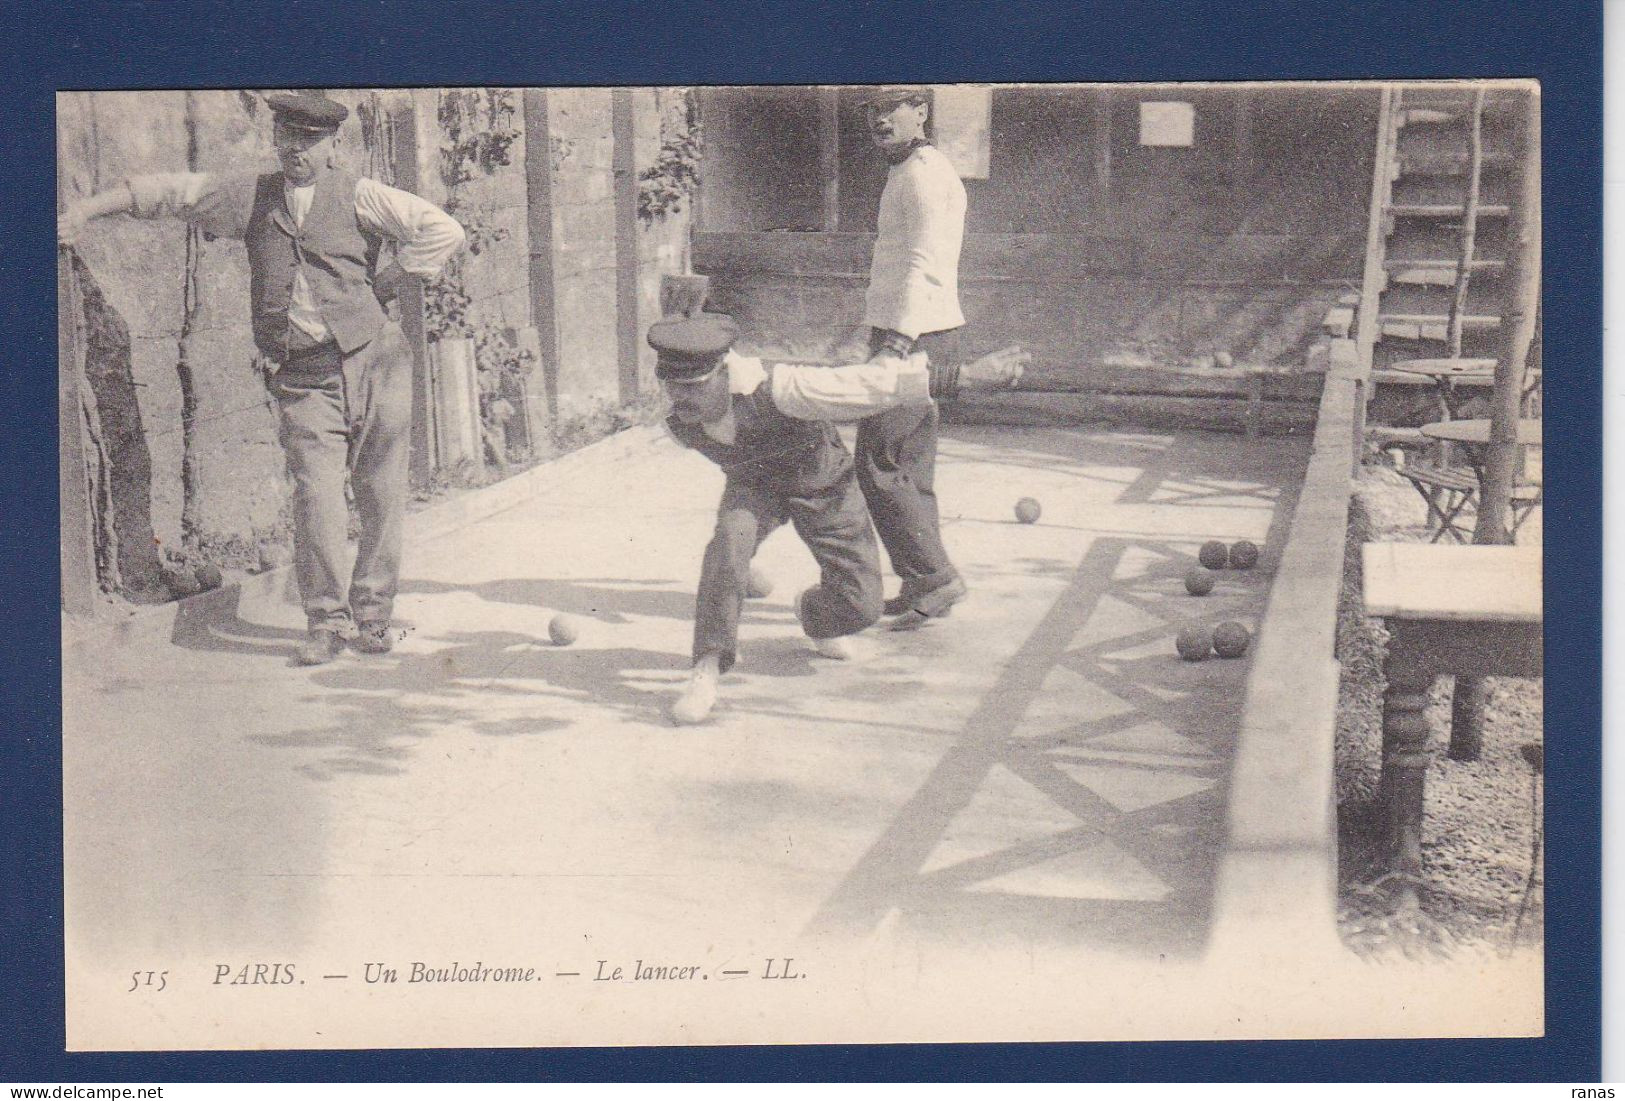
{"left": 853, "top": 330, "right": 960, "bottom": 594}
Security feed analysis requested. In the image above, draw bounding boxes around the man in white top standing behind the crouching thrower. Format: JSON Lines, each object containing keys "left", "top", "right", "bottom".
{"left": 856, "top": 88, "right": 965, "bottom": 628}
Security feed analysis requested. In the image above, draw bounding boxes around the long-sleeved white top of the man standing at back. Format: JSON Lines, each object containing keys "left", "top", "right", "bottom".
{"left": 863, "top": 145, "right": 965, "bottom": 336}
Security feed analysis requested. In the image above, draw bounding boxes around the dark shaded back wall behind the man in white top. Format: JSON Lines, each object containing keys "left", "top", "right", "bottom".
{"left": 696, "top": 88, "right": 1376, "bottom": 375}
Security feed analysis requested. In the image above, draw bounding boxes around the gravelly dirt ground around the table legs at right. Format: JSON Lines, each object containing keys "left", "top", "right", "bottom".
{"left": 1337, "top": 466, "right": 1544, "bottom": 958}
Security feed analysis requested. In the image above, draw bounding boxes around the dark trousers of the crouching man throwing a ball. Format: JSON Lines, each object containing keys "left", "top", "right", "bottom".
{"left": 694, "top": 476, "right": 881, "bottom": 672}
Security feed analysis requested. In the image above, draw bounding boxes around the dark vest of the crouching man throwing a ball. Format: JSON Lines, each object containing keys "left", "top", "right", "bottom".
{"left": 666, "top": 378, "right": 852, "bottom": 497}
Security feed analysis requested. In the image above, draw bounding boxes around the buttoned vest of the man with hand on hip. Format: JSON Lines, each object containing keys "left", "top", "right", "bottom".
{"left": 244, "top": 172, "right": 385, "bottom": 362}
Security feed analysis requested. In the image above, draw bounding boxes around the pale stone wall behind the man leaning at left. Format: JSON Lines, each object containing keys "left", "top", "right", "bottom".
{"left": 59, "top": 89, "right": 691, "bottom": 599}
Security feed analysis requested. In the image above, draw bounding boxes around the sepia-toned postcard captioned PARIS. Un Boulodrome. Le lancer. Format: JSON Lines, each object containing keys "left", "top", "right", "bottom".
{"left": 57, "top": 80, "right": 1540, "bottom": 1052}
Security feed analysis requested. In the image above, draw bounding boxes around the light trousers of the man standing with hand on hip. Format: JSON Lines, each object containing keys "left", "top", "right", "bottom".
{"left": 271, "top": 322, "right": 413, "bottom": 632}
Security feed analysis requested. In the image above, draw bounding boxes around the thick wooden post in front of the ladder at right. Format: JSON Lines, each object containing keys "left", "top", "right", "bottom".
{"left": 1472, "top": 89, "right": 1541, "bottom": 544}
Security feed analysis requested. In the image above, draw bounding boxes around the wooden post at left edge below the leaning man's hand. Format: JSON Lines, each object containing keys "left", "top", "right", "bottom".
{"left": 57, "top": 248, "right": 96, "bottom": 615}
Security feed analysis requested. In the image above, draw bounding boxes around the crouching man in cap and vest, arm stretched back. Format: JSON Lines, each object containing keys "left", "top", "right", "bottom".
{"left": 648, "top": 313, "right": 1022, "bottom": 723}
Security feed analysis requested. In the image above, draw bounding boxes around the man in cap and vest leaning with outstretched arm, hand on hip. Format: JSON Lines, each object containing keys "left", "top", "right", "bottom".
{"left": 57, "top": 93, "right": 463, "bottom": 666}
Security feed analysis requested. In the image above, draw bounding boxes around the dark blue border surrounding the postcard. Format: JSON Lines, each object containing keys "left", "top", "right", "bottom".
{"left": 0, "top": 0, "right": 1602, "bottom": 1083}
